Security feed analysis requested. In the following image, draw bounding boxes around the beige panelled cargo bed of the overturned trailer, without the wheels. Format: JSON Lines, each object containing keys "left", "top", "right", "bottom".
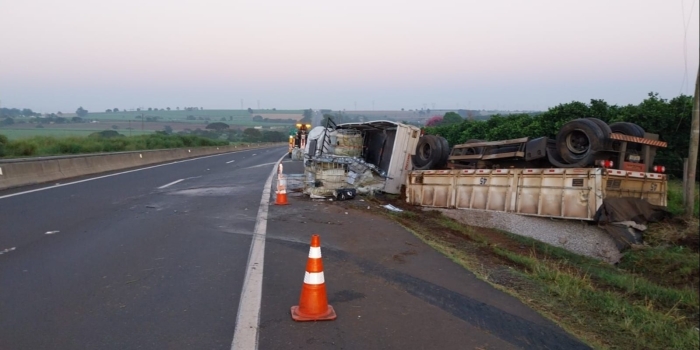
{"left": 406, "top": 168, "right": 667, "bottom": 221}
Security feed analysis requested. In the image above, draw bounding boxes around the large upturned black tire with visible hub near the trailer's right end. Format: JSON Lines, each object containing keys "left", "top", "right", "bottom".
{"left": 556, "top": 119, "right": 609, "bottom": 165}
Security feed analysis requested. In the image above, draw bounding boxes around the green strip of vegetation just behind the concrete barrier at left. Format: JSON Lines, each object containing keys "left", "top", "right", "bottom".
{"left": 0, "top": 130, "right": 229, "bottom": 158}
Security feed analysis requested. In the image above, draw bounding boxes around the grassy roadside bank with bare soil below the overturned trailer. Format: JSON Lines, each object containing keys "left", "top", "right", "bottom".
{"left": 376, "top": 181, "right": 700, "bottom": 349}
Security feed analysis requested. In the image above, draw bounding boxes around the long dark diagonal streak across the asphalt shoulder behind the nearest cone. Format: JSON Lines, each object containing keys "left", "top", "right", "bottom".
{"left": 267, "top": 235, "right": 590, "bottom": 349}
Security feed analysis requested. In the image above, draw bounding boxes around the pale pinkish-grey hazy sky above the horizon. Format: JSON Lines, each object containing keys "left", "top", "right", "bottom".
{"left": 0, "top": 0, "right": 700, "bottom": 113}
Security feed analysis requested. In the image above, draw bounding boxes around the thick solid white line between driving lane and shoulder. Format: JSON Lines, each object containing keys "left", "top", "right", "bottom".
{"left": 231, "top": 156, "right": 285, "bottom": 350}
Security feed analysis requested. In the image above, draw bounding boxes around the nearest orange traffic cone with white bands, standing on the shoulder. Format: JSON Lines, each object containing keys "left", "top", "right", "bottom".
{"left": 292, "top": 235, "right": 337, "bottom": 321}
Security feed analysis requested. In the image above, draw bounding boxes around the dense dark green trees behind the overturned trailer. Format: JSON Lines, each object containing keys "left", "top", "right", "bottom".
{"left": 425, "top": 92, "right": 693, "bottom": 177}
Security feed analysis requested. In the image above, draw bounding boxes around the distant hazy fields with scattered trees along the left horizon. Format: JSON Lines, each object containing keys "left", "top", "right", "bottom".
{"left": 0, "top": 107, "right": 312, "bottom": 142}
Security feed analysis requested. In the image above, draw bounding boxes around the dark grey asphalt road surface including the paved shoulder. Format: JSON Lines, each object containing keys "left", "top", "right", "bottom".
{"left": 0, "top": 148, "right": 587, "bottom": 349}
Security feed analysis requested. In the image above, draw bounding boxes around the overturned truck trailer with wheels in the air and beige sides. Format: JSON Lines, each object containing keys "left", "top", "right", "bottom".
{"left": 406, "top": 118, "right": 667, "bottom": 221}
